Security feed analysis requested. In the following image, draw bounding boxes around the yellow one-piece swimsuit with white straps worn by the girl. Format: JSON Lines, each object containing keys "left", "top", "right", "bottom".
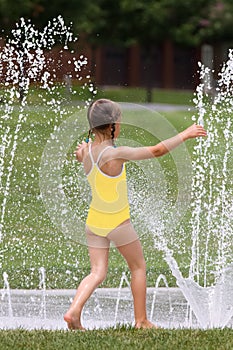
{"left": 86, "top": 144, "right": 130, "bottom": 237}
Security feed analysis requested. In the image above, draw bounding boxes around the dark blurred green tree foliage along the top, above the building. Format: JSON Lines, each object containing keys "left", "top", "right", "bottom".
{"left": 0, "top": 0, "right": 233, "bottom": 48}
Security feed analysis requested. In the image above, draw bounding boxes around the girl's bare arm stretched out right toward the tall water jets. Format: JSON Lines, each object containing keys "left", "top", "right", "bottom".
{"left": 115, "top": 124, "right": 207, "bottom": 161}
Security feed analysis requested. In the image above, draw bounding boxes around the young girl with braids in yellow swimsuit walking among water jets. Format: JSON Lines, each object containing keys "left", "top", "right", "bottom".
{"left": 64, "top": 99, "right": 206, "bottom": 330}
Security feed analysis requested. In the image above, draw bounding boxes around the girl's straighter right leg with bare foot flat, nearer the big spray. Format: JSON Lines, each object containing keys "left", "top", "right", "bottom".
{"left": 117, "top": 239, "right": 157, "bottom": 328}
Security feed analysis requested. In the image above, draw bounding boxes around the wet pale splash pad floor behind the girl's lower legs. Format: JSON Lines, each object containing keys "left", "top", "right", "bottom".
{"left": 3, "top": 274, "right": 229, "bottom": 330}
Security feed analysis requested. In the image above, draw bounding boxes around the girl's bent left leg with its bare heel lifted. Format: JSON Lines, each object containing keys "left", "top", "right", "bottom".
{"left": 64, "top": 247, "right": 109, "bottom": 330}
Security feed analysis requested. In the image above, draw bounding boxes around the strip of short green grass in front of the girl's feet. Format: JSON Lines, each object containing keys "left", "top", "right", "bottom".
{"left": 0, "top": 327, "right": 233, "bottom": 350}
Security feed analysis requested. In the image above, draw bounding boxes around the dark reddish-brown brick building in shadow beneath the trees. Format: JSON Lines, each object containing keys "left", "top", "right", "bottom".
{"left": 0, "top": 37, "right": 226, "bottom": 90}
